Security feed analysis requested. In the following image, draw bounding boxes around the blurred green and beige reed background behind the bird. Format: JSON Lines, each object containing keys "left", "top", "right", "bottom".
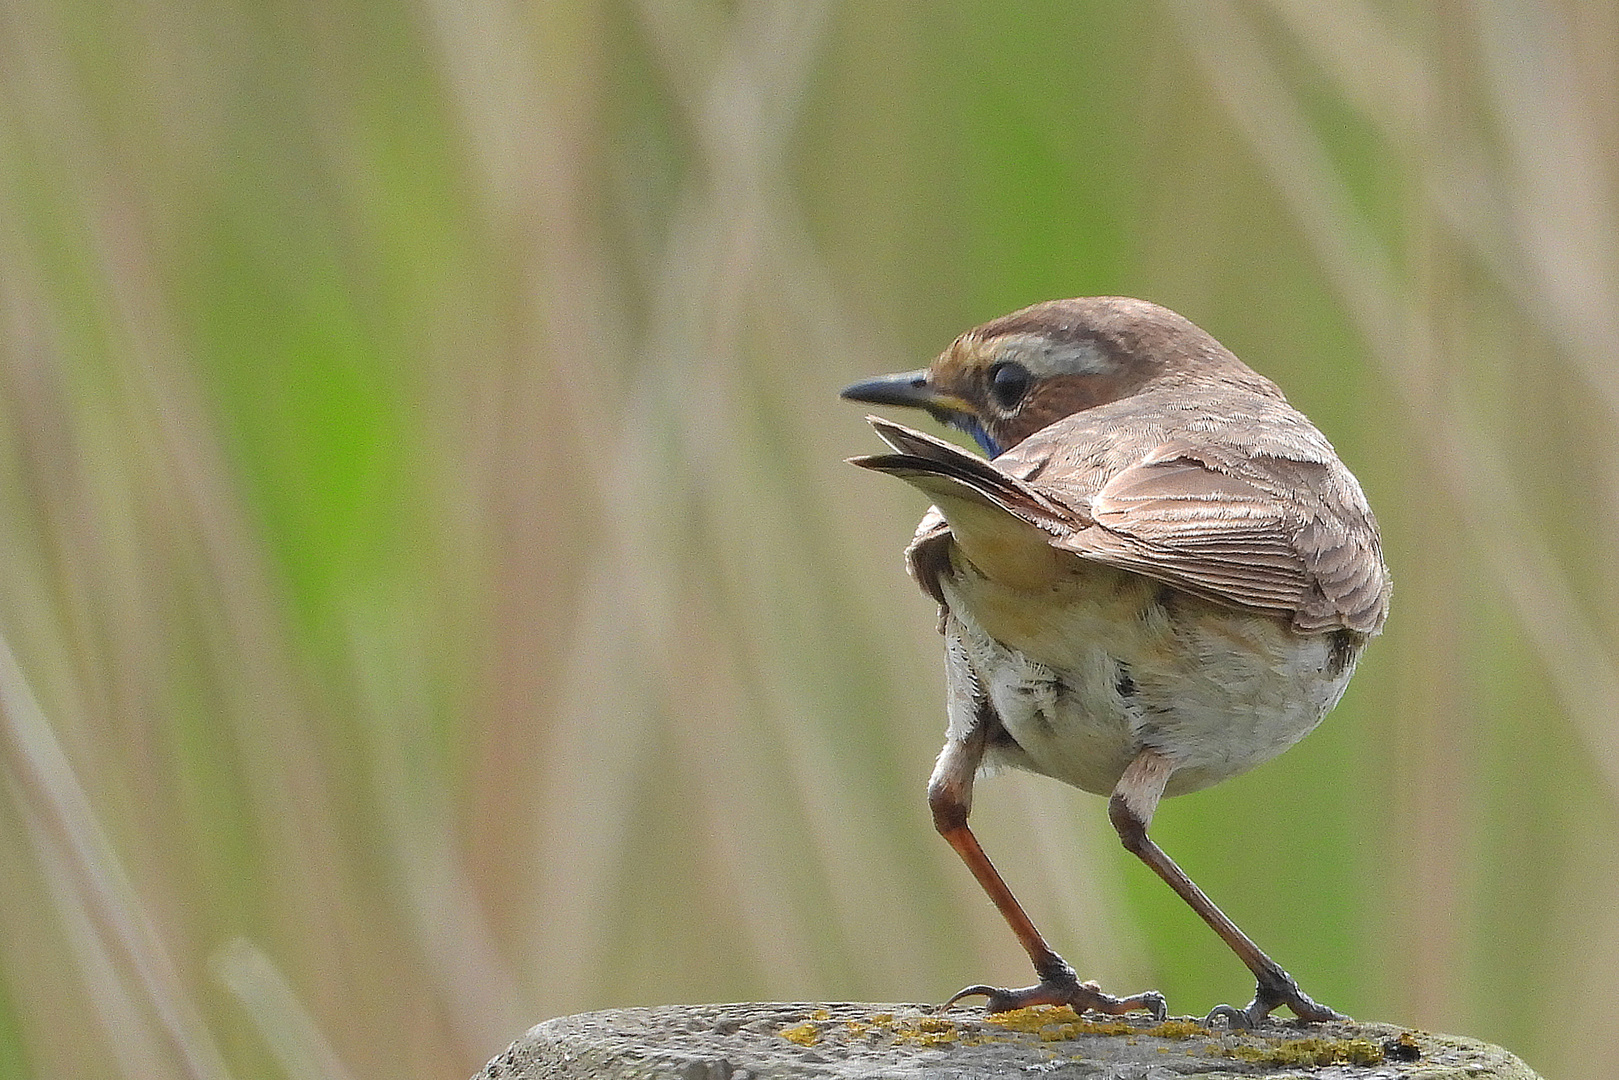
{"left": 0, "top": 0, "right": 1619, "bottom": 1080}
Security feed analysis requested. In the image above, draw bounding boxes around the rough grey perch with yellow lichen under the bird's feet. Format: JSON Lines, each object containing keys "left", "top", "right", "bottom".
{"left": 474, "top": 1002, "right": 1540, "bottom": 1080}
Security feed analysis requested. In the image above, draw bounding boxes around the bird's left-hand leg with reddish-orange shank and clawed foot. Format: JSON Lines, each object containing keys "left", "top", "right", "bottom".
{"left": 928, "top": 724, "right": 1169, "bottom": 1022}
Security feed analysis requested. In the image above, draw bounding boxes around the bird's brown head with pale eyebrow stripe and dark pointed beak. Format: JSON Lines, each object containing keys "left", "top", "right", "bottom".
{"left": 843, "top": 296, "right": 1269, "bottom": 457}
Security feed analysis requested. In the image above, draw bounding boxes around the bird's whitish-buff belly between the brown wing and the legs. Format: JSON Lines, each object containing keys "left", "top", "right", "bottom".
{"left": 941, "top": 560, "right": 1362, "bottom": 795}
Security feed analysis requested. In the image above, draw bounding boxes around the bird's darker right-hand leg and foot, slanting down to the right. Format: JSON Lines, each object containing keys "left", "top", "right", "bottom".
{"left": 1107, "top": 750, "right": 1349, "bottom": 1028}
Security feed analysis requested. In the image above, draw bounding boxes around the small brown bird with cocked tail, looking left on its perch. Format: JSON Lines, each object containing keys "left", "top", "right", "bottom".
{"left": 843, "top": 296, "right": 1389, "bottom": 1027}
